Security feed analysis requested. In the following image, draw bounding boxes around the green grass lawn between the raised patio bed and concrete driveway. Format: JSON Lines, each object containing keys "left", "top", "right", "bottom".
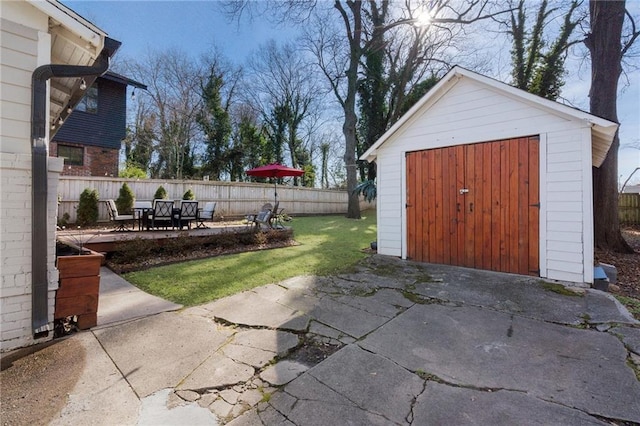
{"left": 124, "top": 210, "right": 376, "bottom": 306}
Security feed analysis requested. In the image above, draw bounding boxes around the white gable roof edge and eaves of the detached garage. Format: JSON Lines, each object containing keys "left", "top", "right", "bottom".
{"left": 360, "top": 66, "right": 618, "bottom": 167}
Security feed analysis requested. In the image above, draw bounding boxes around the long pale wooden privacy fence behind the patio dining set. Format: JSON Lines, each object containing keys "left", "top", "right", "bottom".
{"left": 58, "top": 176, "right": 375, "bottom": 223}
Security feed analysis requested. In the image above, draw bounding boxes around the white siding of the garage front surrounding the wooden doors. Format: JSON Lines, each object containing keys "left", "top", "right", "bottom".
{"left": 376, "top": 77, "right": 593, "bottom": 282}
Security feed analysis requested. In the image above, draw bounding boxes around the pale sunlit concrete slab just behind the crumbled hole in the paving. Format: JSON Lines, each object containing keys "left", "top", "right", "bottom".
{"left": 201, "top": 291, "right": 309, "bottom": 331}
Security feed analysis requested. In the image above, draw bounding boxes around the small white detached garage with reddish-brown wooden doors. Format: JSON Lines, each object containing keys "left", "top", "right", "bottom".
{"left": 361, "top": 67, "right": 618, "bottom": 283}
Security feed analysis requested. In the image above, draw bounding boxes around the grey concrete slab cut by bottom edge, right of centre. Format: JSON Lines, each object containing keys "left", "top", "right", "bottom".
{"left": 412, "top": 382, "right": 608, "bottom": 426}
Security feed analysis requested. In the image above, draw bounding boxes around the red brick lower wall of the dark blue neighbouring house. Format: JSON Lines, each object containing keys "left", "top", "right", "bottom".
{"left": 49, "top": 142, "right": 120, "bottom": 177}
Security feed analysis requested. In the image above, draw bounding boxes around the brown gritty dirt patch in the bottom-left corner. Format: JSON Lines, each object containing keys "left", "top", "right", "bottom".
{"left": 0, "top": 339, "right": 86, "bottom": 426}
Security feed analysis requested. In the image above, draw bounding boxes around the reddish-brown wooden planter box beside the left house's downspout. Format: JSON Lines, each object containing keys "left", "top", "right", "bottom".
{"left": 54, "top": 246, "right": 104, "bottom": 330}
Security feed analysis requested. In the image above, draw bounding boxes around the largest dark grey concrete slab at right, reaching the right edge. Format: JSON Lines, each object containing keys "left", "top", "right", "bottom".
{"left": 360, "top": 305, "right": 640, "bottom": 422}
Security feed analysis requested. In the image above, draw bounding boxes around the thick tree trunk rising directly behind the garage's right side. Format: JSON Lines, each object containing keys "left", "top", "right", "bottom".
{"left": 585, "top": 0, "right": 633, "bottom": 253}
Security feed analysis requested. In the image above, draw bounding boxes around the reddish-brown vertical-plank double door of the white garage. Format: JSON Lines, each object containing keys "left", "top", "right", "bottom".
{"left": 406, "top": 136, "right": 540, "bottom": 275}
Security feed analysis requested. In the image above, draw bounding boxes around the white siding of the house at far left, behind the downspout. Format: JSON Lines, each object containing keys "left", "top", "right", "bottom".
{"left": 0, "top": 6, "right": 61, "bottom": 352}
